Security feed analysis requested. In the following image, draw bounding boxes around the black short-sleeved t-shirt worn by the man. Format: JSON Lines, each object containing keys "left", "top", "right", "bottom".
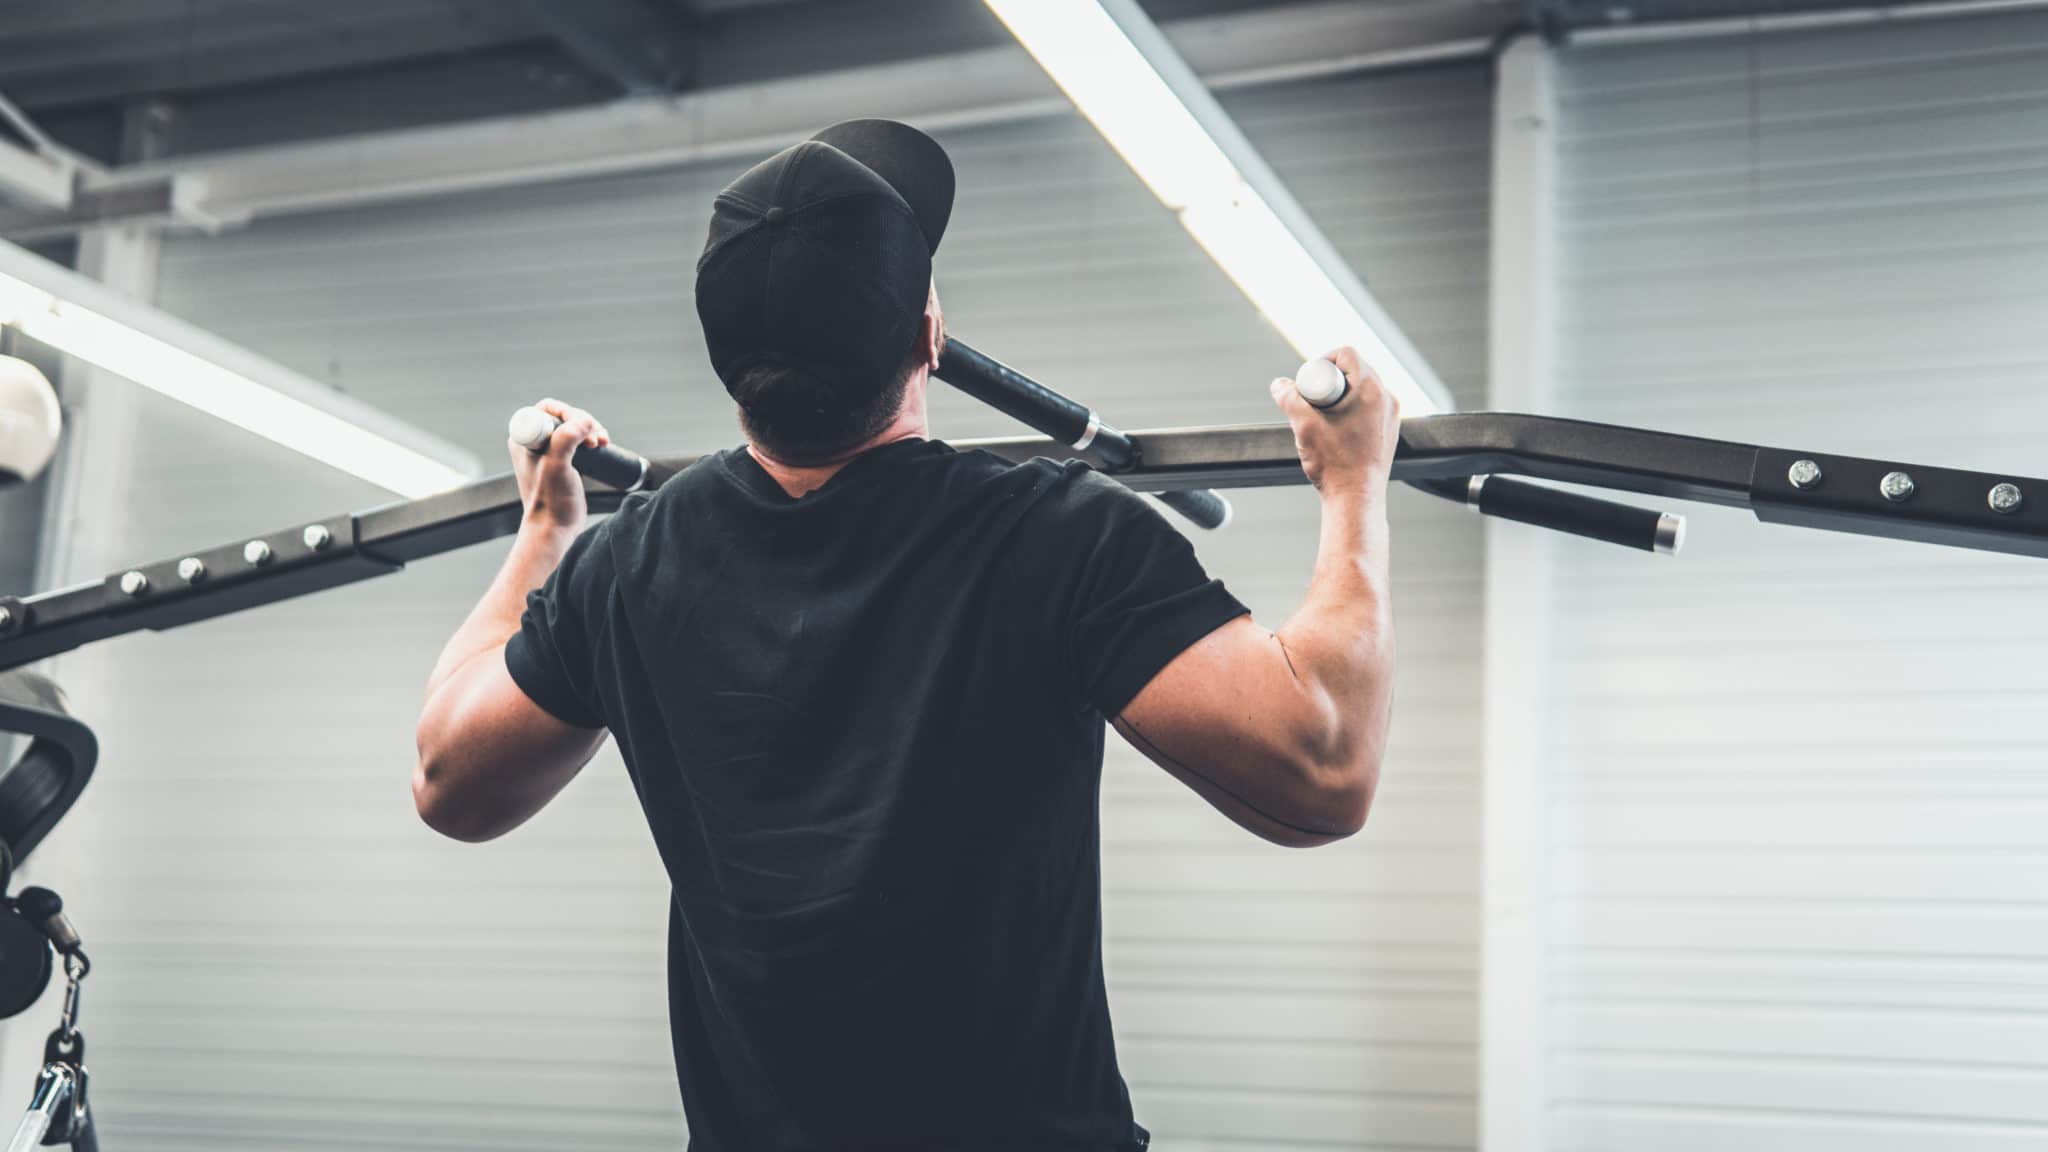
{"left": 506, "top": 441, "right": 1245, "bottom": 1152}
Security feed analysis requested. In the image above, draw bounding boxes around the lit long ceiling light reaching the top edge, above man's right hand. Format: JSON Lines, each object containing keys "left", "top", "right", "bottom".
{"left": 987, "top": 0, "right": 1452, "bottom": 416}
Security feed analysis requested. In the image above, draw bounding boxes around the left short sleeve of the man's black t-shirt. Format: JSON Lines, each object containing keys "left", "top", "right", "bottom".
{"left": 506, "top": 521, "right": 614, "bottom": 728}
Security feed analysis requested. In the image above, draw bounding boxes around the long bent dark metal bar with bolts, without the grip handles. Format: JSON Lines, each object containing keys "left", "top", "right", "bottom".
{"left": 0, "top": 412, "right": 2048, "bottom": 668}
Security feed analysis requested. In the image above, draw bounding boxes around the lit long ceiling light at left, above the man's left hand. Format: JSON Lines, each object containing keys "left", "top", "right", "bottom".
{"left": 0, "top": 242, "right": 477, "bottom": 498}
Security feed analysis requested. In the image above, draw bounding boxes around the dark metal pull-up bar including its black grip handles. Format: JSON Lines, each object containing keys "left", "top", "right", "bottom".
{"left": 0, "top": 340, "right": 2048, "bottom": 670}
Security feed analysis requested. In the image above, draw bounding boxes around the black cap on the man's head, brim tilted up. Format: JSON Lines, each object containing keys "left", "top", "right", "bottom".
{"left": 696, "top": 119, "right": 952, "bottom": 408}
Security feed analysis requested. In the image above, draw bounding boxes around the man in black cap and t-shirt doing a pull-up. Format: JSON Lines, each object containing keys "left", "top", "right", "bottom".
{"left": 414, "top": 121, "right": 1397, "bottom": 1152}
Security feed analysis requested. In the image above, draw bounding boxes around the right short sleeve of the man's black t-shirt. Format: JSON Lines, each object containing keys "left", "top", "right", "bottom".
{"left": 1057, "top": 465, "right": 1247, "bottom": 715}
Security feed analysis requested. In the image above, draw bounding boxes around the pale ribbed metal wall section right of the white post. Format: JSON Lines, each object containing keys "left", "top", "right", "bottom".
{"left": 1532, "top": 14, "right": 2048, "bottom": 1152}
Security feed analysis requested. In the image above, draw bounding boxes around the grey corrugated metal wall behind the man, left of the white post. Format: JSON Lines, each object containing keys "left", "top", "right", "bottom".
{"left": 8, "top": 66, "right": 1491, "bottom": 1152}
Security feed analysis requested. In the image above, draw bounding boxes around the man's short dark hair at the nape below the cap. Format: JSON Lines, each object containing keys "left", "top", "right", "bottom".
{"left": 731, "top": 357, "right": 918, "bottom": 465}
